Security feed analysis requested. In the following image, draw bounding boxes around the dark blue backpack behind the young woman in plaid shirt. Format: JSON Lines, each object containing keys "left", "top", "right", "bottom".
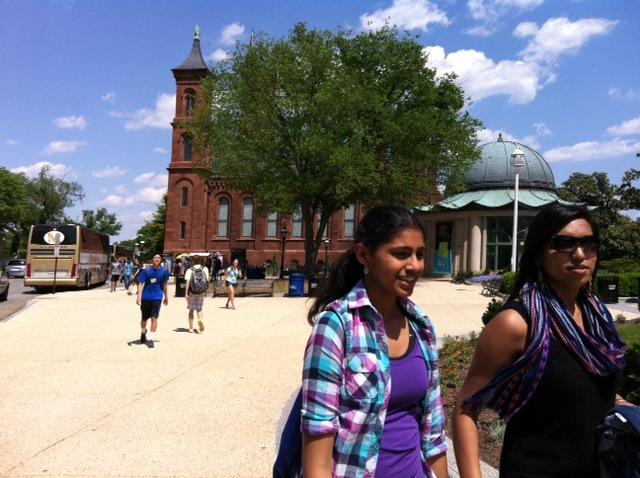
{"left": 273, "top": 389, "right": 302, "bottom": 478}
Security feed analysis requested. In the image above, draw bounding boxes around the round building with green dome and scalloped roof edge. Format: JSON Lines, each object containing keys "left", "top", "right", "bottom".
{"left": 419, "top": 135, "right": 568, "bottom": 275}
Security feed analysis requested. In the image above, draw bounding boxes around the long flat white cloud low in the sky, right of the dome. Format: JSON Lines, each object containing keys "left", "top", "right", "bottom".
{"left": 542, "top": 138, "right": 640, "bottom": 162}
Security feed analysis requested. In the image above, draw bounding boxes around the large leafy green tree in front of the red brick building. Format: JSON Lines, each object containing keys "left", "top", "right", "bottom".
{"left": 189, "top": 24, "right": 479, "bottom": 272}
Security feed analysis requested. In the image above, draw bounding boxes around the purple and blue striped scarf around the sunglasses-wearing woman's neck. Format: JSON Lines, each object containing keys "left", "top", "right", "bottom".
{"left": 465, "top": 282, "right": 627, "bottom": 420}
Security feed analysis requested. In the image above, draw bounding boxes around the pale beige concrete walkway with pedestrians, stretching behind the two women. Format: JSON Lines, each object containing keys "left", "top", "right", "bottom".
{"left": 0, "top": 281, "right": 490, "bottom": 478}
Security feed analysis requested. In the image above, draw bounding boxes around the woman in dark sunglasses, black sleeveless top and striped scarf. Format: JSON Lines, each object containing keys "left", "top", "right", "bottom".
{"left": 454, "top": 204, "right": 628, "bottom": 478}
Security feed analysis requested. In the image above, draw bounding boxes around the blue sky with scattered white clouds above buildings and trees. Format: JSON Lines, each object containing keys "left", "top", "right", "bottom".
{"left": 0, "top": 0, "right": 640, "bottom": 240}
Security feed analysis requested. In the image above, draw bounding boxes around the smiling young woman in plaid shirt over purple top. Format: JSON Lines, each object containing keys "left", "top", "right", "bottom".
{"left": 301, "top": 206, "right": 448, "bottom": 478}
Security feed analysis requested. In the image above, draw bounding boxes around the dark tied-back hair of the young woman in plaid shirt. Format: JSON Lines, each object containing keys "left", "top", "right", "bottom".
{"left": 307, "top": 206, "right": 427, "bottom": 324}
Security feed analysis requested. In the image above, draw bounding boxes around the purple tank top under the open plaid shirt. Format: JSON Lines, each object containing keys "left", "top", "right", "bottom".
{"left": 376, "top": 336, "right": 429, "bottom": 478}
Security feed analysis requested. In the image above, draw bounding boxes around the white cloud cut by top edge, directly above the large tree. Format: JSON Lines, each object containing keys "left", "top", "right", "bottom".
{"left": 360, "top": 0, "right": 451, "bottom": 32}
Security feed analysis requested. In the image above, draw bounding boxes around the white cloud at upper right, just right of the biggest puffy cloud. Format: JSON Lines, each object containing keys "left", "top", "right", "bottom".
{"left": 513, "top": 17, "right": 618, "bottom": 63}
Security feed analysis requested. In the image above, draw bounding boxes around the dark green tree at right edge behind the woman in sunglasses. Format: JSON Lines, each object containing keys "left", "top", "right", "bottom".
{"left": 558, "top": 169, "right": 640, "bottom": 259}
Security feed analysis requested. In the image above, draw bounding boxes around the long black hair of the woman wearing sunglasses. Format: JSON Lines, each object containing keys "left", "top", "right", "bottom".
{"left": 508, "top": 203, "right": 600, "bottom": 301}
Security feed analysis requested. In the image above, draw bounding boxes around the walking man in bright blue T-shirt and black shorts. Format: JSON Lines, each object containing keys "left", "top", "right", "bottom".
{"left": 136, "top": 254, "right": 169, "bottom": 348}
